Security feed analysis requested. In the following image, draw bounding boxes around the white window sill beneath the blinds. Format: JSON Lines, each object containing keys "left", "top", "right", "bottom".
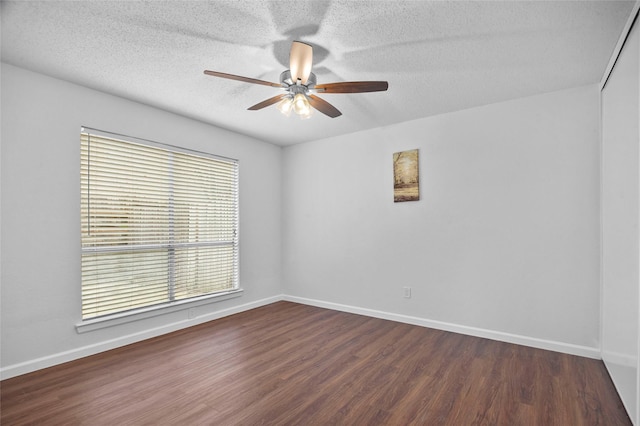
{"left": 76, "top": 288, "right": 244, "bottom": 334}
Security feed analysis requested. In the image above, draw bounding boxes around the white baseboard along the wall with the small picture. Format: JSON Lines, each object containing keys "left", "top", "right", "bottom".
{"left": 284, "top": 295, "right": 602, "bottom": 359}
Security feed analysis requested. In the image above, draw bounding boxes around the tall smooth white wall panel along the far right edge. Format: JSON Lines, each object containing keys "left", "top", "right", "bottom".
{"left": 602, "top": 15, "right": 640, "bottom": 424}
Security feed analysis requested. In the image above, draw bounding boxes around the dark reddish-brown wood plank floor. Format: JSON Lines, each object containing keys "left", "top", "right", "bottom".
{"left": 0, "top": 302, "right": 631, "bottom": 426}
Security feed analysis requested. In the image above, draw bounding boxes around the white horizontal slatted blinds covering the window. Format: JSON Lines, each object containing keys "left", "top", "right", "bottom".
{"left": 80, "top": 131, "right": 238, "bottom": 319}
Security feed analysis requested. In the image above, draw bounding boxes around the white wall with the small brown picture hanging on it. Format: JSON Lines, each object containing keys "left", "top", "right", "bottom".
{"left": 283, "top": 86, "right": 600, "bottom": 357}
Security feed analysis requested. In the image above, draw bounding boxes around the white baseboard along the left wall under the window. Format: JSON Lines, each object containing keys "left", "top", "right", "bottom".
{"left": 0, "top": 295, "right": 283, "bottom": 380}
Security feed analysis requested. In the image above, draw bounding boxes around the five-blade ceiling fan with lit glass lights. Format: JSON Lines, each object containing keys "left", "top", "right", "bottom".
{"left": 204, "top": 41, "right": 389, "bottom": 118}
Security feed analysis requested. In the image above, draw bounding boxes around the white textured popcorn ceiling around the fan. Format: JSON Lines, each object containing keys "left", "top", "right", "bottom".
{"left": 0, "top": 0, "right": 635, "bottom": 145}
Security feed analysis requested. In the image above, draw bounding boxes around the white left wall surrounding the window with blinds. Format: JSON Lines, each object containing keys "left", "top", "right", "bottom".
{"left": 0, "top": 64, "right": 282, "bottom": 378}
